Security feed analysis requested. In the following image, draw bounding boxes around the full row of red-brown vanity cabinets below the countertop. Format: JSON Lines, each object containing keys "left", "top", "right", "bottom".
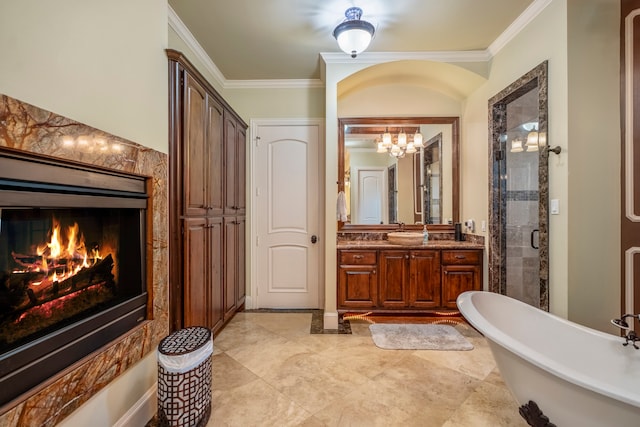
{"left": 338, "top": 249, "right": 482, "bottom": 312}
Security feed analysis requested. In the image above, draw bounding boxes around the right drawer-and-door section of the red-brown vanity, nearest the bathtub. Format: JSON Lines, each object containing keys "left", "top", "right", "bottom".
{"left": 442, "top": 250, "right": 482, "bottom": 309}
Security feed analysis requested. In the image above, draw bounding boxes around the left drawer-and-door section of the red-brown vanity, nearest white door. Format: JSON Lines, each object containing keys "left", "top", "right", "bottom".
{"left": 338, "top": 250, "right": 378, "bottom": 309}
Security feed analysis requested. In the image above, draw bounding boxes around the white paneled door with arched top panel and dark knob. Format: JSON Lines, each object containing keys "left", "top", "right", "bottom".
{"left": 253, "top": 123, "right": 324, "bottom": 308}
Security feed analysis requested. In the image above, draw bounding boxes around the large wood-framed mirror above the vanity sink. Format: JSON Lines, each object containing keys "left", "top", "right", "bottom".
{"left": 338, "top": 117, "right": 459, "bottom": 230}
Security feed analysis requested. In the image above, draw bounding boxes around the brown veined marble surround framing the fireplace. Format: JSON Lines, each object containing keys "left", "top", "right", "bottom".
{"left": 0, "top": 94, "right": 169, "bottom": 426}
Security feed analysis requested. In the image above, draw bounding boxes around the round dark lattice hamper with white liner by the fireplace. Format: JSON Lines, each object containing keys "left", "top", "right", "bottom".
{"left": 158, "top": 326, "right": 213, "bottom": 427}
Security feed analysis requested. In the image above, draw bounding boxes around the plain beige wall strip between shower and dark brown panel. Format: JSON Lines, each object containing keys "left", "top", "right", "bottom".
{"left": 566, "top": 0, "right": 621, "bottom": 333}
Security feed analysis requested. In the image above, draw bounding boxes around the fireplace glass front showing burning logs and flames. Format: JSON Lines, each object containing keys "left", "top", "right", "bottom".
{"left": 0, "top": 208, "right": 144, "bottom": 353}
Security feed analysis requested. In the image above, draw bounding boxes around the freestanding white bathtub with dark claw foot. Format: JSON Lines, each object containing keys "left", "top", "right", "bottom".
{"left": 457, "top": 291, "right": 640, "bottom": 427}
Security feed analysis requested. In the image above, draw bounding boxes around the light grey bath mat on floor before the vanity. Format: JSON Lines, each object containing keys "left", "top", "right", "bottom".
{"left": 369, "top": 323, "right": 473, "bottom": 350}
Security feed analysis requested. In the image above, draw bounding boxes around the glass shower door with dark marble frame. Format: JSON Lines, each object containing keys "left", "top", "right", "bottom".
{"left": 489, "top": 62, "right": 549, "bottom": 310}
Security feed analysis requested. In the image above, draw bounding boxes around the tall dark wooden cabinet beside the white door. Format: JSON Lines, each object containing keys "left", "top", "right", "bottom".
{"left": 167, "top": 50, "right": 247, "bottom": 334}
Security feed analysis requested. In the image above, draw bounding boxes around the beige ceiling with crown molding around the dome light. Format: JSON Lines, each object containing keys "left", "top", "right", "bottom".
{"left": 169, "top": 0, "right": 539, "bottom": 80}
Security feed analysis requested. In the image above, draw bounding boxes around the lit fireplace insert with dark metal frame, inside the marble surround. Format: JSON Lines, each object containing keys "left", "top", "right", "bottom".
{"left": 0, "top": 148, "right": 150, "bottom": 406}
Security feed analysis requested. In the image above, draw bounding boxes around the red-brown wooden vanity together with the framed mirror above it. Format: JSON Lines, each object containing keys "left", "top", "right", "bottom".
{"left": 336, "top": 117, "right": 484, "bottom": 315}
